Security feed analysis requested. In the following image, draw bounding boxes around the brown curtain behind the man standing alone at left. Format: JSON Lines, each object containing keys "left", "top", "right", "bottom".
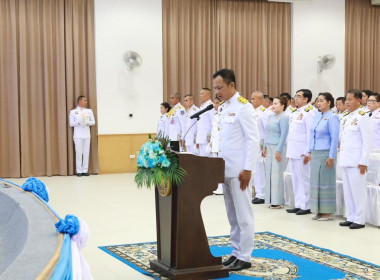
{"left": 0, "top": 0, "right": 98, "bottom": 177}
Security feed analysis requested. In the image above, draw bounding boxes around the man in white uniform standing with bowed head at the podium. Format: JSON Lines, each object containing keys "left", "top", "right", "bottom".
{"left": 213, "top": 69, "right": 259, "bottom": 271}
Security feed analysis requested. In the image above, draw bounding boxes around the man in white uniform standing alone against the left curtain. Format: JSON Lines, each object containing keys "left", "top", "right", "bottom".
{"left": 69, "top": 95, "right": 95, "bottom": 177}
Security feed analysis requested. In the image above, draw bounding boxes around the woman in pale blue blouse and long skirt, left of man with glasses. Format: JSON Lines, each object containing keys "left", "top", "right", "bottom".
{"left": 263, "top": 97, "right": 289, "bottom": 209}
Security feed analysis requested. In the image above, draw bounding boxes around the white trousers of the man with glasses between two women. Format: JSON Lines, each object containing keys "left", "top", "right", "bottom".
{"left": 289, "top": 158, "right": 310, "bottom": 210}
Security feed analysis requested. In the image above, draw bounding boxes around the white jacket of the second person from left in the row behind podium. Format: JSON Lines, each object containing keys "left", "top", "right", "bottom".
{"left": 169, "top": 103, "right": 186, "bottom": 141}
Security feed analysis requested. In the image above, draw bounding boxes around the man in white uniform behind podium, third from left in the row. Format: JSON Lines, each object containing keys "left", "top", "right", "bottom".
{"left": 183, "top": 94, "right": 199, "bottom": 154}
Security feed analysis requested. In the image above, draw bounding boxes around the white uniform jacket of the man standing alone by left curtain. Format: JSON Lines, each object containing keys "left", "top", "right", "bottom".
{"left": 69, "top": 106, "right": 95, "bottom": 139}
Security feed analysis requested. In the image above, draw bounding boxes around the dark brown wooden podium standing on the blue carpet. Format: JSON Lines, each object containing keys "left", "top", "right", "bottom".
{"left": 150, "top": 153, "right": 229, "bottom": 280}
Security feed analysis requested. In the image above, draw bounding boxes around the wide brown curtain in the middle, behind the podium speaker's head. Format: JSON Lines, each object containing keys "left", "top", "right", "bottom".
{"left": 163, "top": 0, "right": 291, "bottom": 101}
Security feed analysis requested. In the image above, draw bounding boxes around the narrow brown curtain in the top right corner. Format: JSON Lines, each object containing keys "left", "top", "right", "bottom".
{"left": 345, "top": 0, "right": 380, "bottom": 92}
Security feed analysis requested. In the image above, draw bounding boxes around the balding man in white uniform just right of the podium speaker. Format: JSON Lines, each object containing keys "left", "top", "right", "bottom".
{"left": 251, "top": 91, "right": 268, "bottom": 204}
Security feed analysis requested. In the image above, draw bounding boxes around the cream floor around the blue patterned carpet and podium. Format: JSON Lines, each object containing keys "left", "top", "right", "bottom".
{"left": 11, "top": 174, "right": 380, "bottom": 280}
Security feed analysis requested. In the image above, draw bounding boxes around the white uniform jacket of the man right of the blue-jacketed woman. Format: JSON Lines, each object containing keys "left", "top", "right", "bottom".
{"left": 339, "top": 108, "right": 372, "bottom": 167}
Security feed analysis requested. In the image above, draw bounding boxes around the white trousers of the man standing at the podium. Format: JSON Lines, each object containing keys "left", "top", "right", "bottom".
{"left": 223, "top": 178, "right": 255, "bottom": 262}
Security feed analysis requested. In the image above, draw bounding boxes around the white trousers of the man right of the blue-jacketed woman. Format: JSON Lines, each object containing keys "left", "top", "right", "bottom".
{"left": 342, "top": 167, "right": 367, "bottom": 225}
